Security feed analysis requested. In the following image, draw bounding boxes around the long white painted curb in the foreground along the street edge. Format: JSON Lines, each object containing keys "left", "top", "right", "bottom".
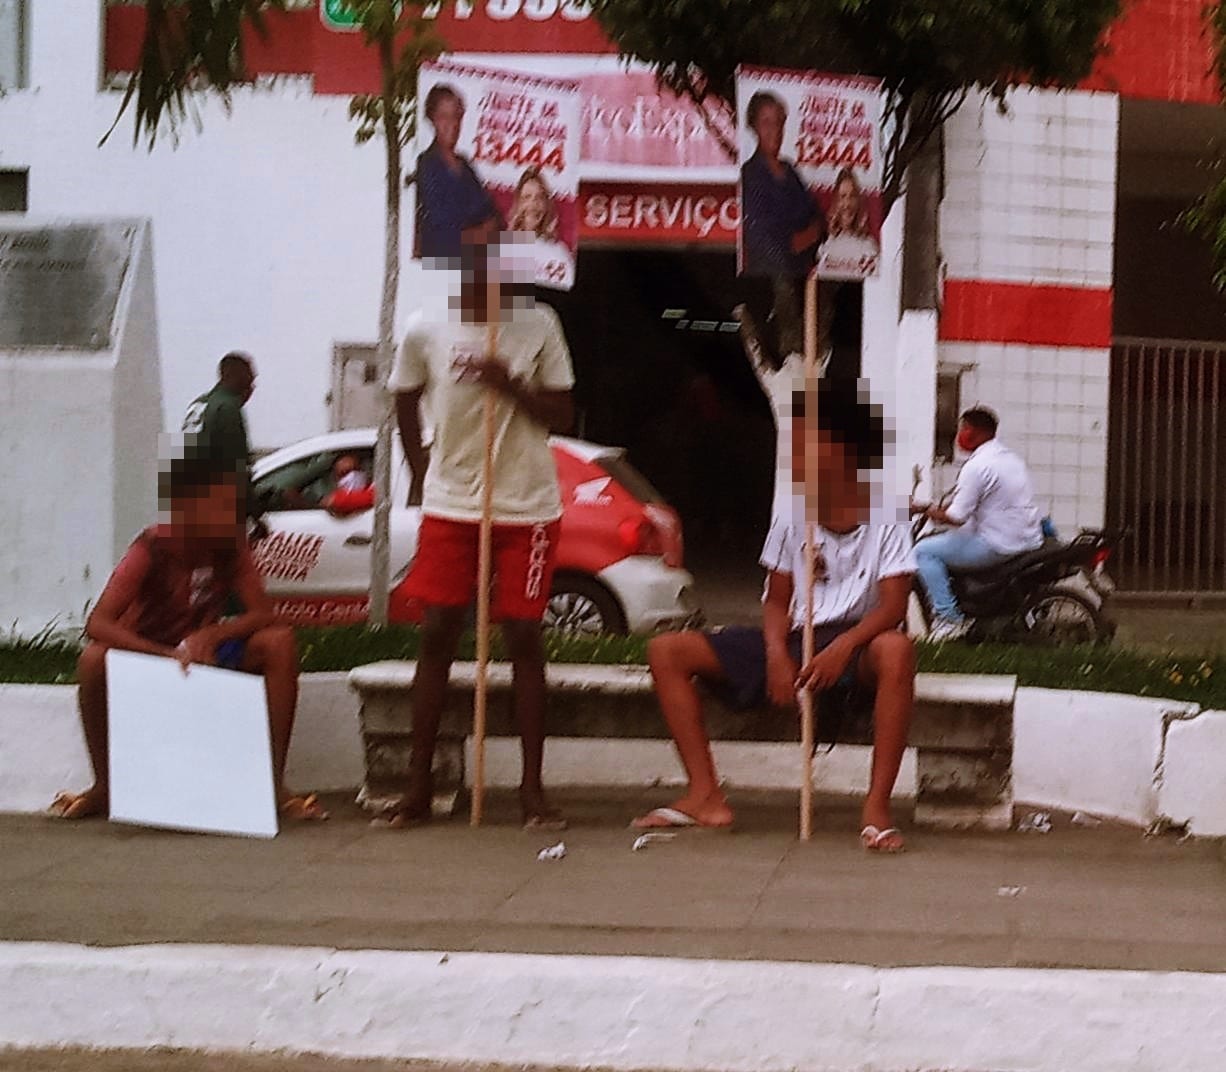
{"left": 0, "top": 943, "right": 1226, "bottom": 1072}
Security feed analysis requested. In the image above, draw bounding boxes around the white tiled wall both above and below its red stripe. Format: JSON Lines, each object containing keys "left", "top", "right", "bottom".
{"left": 940, "top": 90, "right": 1119, "bottom": 529}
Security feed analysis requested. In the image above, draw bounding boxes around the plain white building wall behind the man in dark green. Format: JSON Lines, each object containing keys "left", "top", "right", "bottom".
{"left": 0, "top": 0, "right": 422, "bottom": 446}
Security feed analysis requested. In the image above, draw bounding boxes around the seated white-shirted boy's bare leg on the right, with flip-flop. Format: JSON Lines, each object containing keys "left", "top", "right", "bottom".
{"left": 861, "top": 632, "right": 916, "bottom": 849}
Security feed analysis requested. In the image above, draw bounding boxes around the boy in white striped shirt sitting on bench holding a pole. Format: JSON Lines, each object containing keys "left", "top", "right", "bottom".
{"left": 633, "top": 380, "right": 916, "bottom": 852}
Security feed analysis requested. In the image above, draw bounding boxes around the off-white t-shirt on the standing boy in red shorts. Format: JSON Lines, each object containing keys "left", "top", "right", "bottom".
{"left": 387, "top": 304, "right": 575, "bottom": 525}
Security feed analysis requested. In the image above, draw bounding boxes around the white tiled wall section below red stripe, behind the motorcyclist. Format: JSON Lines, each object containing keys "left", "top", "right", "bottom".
{"left": 938, "top": 342, "right": 1110, "bottom": 532}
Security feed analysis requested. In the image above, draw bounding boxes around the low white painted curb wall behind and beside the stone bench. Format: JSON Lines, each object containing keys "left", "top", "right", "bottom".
{"left": 0, "top": 672, "right": 1226, "bottom": 837}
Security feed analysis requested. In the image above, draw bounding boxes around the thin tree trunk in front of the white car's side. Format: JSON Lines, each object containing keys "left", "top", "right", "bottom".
{"left": 370, "top": 21, "right": 401, "bottom": 627}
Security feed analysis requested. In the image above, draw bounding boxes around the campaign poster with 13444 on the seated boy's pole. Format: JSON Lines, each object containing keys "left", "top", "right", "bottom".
{"left": 737, "top": 66, "right": 883, "bottom": 280}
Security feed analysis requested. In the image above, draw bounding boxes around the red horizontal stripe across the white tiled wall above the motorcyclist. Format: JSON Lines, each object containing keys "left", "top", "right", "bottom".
{"left": 940, "top": 280, "right": 1112, "bottom": 350}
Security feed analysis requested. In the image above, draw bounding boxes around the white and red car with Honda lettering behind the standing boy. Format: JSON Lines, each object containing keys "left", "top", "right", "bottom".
{"left": 251, "top": 428, "right": 696, "bottom": 633}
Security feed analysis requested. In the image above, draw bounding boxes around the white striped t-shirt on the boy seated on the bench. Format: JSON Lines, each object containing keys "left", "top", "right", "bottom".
{"left": 761, "top": 503, "right": 916, "bottom": 629}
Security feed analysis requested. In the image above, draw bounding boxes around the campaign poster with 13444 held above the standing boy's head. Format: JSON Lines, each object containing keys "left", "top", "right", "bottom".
{"left": 414, "top": 61, "right": 582, "bottom": 291}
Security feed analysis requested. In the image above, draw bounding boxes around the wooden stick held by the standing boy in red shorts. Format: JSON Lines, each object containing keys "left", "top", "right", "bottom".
{"left": 468, "top": 296, "right": 501, "bottom": 827}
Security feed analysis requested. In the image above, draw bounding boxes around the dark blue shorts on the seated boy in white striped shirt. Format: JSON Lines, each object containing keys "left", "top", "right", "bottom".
{"left": 702, "top": 622, "right": 875, "bottom": 741}
